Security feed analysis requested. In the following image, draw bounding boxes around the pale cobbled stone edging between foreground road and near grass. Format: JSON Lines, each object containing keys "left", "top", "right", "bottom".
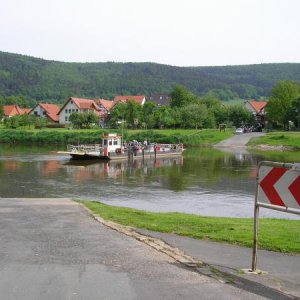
{"left": 77, "top": 202, "right": 206, "bottom": 267}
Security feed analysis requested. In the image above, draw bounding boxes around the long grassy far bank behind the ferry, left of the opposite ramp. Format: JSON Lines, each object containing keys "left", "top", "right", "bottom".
{"left": 0, "top": 128, "right": 232, "bottom": 146}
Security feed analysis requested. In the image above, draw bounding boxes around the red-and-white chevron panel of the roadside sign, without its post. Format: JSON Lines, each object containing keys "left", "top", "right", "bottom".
{"left": 257, "top": 165, "right": 300, "bottom": 210}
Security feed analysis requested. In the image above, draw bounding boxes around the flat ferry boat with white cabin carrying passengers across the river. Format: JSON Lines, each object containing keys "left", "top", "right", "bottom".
{"left": 59, "top": 133, "right": 184, "bottom": 160}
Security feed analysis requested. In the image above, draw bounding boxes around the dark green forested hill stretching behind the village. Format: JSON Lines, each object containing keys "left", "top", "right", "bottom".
{"left": 0, "top": 52, "right": 300, "bottom": 102}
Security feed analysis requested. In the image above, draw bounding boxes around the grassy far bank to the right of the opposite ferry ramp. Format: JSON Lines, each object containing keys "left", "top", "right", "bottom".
{"left": 248, "top": 132, "right": 300, "bottom": 151}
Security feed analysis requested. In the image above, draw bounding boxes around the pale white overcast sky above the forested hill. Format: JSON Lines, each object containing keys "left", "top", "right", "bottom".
{"left": 0, "top": 0, "right": 300, "bottom": 66}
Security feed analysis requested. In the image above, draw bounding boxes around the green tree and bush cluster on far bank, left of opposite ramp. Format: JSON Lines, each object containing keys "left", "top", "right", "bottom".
{"left": 108, "top": 86, "right": 255, "bottom": 129}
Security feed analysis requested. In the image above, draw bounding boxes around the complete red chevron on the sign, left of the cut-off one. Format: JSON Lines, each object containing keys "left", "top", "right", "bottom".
{"left": 260, "top": 168, "right": 287, "bottom": 206}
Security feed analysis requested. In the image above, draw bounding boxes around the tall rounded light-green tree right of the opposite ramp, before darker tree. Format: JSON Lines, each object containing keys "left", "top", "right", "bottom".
{"left": 266, "top": 80, "right": 299, "bottom": 129}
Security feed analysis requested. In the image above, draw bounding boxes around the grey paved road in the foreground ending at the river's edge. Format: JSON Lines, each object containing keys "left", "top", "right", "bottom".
{"left": 0, "top": 198, "right": 268, "bottom": 300}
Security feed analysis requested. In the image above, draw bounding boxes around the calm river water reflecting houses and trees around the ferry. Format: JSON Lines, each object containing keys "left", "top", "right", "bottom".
{"left": 0, "top": 145, "right": 300, "bottom": 219}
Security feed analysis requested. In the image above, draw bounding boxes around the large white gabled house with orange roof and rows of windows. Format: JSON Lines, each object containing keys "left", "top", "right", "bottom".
{"left": 58, "top": 97, "right": 104, "bottom": 124}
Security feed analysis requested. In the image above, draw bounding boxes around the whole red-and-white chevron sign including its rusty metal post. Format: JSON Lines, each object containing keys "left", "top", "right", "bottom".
{"left": 251, "top": 161, "right": 300, "bottom": 272}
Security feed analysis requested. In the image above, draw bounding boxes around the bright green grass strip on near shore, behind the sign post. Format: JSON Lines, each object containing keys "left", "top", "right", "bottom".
{"left": 80, "top": 201, "right": 300, "bottom": 253}
